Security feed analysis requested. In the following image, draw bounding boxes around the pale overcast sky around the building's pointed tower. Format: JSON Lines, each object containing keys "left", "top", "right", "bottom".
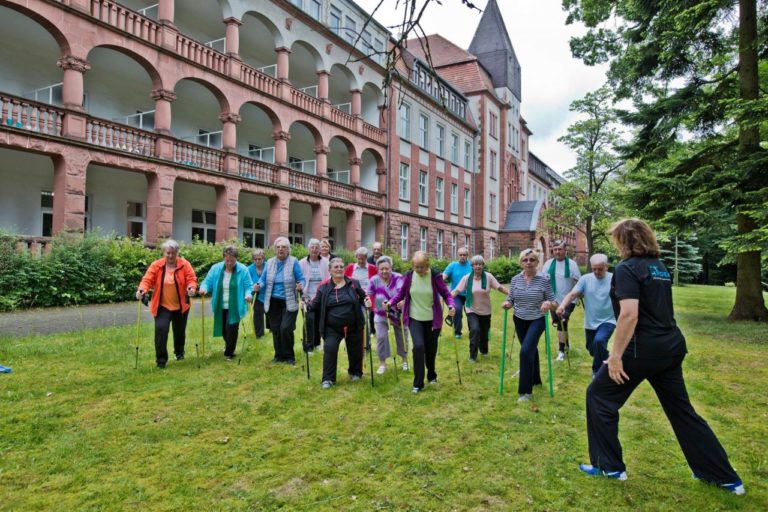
{"left": 356, "top": 0, "right": 605, "bottom": 174}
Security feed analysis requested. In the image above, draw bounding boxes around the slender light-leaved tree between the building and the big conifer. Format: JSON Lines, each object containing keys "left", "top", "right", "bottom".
{"left": 545, "top": 87, "right": 622, "bottom": 256}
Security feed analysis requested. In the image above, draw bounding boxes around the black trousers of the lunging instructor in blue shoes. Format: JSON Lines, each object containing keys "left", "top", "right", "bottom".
{"left": 587, "top": 355, "right": 739, "bottom": 484}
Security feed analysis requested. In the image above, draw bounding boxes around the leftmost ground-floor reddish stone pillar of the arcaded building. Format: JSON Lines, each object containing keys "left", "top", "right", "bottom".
{"left": 52, "top": 152, "right": 89, "bottom": 235}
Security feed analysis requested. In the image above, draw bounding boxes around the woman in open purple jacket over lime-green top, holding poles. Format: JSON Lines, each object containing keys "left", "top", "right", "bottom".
{"left": 384, "top": 251, "right": 456, "bottom": 393}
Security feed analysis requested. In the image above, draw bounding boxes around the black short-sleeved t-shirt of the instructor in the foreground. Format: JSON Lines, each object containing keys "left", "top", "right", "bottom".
{"left": 611, "top": 256, "right": 687, "bottom": 358}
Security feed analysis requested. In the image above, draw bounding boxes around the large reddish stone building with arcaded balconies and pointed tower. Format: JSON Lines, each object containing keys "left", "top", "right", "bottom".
{"left": 0, "top": 0, "right": 576, "bottom": 257}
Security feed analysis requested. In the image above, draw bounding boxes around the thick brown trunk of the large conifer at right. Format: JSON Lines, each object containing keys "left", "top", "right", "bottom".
{"left": 728, "top": 0, "right": 768, "bottom": 321}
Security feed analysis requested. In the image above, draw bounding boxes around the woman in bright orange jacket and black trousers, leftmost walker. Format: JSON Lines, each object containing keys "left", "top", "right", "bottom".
{"left": 136, "top": 240, "right": 197, "bottom": 368}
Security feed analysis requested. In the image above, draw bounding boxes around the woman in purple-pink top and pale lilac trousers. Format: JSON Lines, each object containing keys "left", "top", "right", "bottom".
{"left": 368, "top": 256, "right": 408, "bottom": 375}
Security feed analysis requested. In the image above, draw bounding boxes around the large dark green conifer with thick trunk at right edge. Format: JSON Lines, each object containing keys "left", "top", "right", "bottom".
{"left": 563, "top": 0, "right": 768, "bottom": 321}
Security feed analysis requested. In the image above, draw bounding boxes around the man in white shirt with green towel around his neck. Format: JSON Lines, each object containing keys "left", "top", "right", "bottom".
{"left": 542, "top": 240, "right": 581, "bottom": 361}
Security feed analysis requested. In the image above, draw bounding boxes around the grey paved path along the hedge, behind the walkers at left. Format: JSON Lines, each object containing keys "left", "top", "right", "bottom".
{"left": 0, "top": 299, "right": 211, "bottom": 336}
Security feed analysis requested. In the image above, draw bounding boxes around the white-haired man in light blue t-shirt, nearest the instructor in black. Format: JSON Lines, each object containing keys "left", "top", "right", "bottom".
{"left": 557, "top": 254, "right": 616, "bottom": 378}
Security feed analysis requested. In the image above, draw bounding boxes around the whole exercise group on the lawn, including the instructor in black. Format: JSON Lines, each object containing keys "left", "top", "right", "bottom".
{"left": 136, "top": 219, "right": 744, "bottom": 494}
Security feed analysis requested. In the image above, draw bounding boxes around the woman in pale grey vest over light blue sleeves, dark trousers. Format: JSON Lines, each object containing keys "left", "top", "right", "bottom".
{"left": 254, "top": 236, "right": 304, "bottom": 364}
